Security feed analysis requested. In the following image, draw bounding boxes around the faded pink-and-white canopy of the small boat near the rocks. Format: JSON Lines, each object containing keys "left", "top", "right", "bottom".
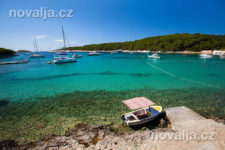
{"left": 123, "top": 97, "right": 155, "bottom": 110}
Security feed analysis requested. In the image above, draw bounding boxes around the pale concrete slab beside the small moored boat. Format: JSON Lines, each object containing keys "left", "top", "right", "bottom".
{"left": 165, "top": 106, "right": 225, "bottom": 150}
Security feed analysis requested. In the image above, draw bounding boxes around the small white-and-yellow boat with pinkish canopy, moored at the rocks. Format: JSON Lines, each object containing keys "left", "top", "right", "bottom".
{"left": 121, "top": 97, "right": 163, "bottom": 126}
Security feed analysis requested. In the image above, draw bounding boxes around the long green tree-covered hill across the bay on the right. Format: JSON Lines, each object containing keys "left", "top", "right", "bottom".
{"left": 67, "top": 33, "right": 225, "bottom": 51}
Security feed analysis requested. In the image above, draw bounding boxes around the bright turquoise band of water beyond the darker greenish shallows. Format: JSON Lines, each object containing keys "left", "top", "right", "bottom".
{"left": 0, "top": 53, "right": 225, "bottom": 101}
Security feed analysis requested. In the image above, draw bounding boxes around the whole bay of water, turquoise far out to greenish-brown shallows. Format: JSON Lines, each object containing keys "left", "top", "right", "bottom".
{"left": 0, "top": 52, "right": 225, "bottom": 143}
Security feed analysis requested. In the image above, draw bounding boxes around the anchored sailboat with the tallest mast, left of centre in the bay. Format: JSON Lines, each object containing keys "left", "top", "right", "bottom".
{"left": 48, "top": 27, "right": 77, "bottom": 64}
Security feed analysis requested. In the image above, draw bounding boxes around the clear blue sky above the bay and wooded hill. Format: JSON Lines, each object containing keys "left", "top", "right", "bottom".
{"left": 0, "top": 0, "right": 225, "bottom": 50}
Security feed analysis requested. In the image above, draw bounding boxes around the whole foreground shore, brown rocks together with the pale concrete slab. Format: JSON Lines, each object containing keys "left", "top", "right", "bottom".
{"left": 0, "top": 107, "right": 225, "bottom": 150}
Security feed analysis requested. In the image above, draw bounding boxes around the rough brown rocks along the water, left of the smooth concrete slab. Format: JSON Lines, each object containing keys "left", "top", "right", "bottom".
{"left": 0, "top": 113, "right": 171, "bottom": 150}
